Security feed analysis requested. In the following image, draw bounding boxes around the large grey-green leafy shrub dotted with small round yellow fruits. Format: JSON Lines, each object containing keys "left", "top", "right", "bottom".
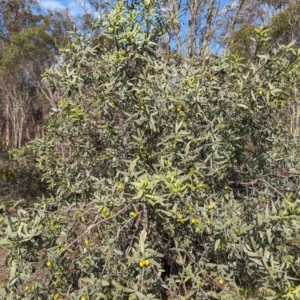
{"left": 1, "top": 1, "right": 300, "bottom": 300}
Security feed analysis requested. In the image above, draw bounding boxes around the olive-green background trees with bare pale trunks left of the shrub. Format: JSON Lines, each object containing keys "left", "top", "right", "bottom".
{"left": 0, "top": 0, "right": 70, "bottom": 147}
